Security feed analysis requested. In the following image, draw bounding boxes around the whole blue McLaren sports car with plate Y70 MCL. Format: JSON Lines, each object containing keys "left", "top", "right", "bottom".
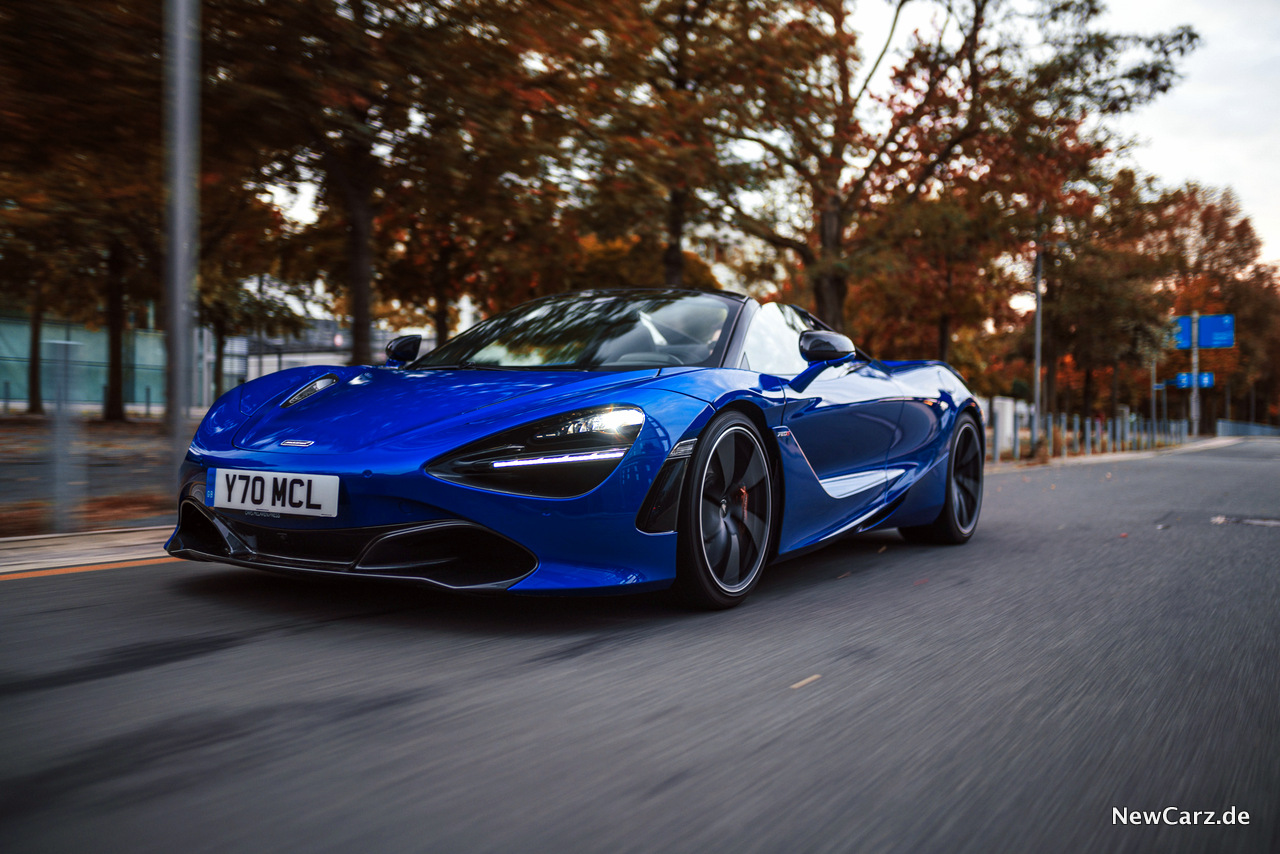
{"left": 166, "top": 291, "right": 984, "bottom": 608}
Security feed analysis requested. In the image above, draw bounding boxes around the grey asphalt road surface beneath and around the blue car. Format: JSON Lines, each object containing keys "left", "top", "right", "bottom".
{"left": 0, "top": 440, "right": 1280, "bottom": 854}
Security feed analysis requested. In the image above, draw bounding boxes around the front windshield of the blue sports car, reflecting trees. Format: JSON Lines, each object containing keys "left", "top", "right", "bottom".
{"left": 411, "top": 291, "right": 740, "bottom": 370}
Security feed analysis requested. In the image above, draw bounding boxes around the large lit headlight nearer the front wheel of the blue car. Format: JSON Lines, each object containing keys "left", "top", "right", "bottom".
{"left": 426, "top": 406, "right": 644, "bottom": 498}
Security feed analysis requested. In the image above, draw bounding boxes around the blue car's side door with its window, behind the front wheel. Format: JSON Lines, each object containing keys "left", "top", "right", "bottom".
{"left": 742, "top": 303, "right": 902, "bottom": 517}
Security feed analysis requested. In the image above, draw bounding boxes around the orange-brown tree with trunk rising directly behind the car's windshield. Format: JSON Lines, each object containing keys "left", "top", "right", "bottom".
{"left": 575, "top": 0, "right": 787, "bottom": 288}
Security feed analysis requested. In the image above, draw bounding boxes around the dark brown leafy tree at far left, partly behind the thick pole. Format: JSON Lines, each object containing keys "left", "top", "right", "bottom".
{"left": 0, "top": 0, "right": 296, "bottom": 420}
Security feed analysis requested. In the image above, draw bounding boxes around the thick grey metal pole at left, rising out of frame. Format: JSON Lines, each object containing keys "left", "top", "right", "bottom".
{"left": 164, "top": 0, "right": 200, "bottom": 465}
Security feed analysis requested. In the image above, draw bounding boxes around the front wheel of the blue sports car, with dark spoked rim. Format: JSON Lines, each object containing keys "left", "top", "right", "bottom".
{"left": 676, "top": 412, "right": 778, "bottom": 609}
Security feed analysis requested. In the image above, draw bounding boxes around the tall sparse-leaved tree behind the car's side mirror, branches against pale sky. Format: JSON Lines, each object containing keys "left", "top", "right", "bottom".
{"left": 732, "top": 0, "right": 1196, "bottom": 326}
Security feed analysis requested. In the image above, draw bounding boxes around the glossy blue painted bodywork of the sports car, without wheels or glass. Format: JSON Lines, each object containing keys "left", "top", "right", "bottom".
{"left": 170, "top": 294, "right": 982, "bottom": 593}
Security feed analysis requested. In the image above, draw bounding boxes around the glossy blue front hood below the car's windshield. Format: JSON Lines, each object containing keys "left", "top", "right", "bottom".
{"left": 234, "top": 369, "right": 658, "bottom": 453}
